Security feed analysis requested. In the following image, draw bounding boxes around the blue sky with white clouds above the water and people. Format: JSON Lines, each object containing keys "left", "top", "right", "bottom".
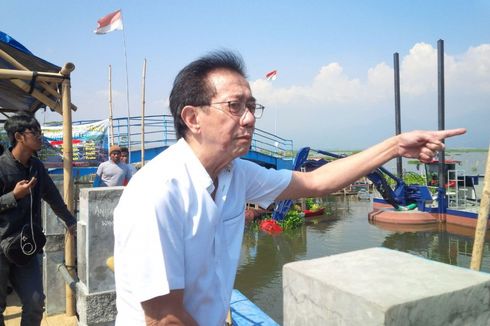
{"left": 0, "top": 0, "right": 490, "bottom": 150}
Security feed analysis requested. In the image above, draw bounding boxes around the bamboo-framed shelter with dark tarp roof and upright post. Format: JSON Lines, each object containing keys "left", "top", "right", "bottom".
{"left": 0, "top": 32, "right": 76, "bottom": 316}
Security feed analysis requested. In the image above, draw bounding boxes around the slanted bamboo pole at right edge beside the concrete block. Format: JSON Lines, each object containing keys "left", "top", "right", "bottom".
{"left": 470, "top": 146, "right": 490, "bottom": 271}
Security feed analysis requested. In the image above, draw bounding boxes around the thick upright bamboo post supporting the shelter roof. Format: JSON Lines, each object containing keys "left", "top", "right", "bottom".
{"left": 61, "top": 64, "right": 76, "bottom": 316}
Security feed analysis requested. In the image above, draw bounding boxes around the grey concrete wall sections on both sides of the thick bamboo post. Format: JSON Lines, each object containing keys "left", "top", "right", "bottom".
{"left": 42, "top": 180, "right": 123, "bottom": 326}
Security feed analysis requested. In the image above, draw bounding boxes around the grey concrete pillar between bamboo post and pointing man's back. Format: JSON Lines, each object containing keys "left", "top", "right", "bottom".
{"left": 77, "top": 187, "right": 123, "bottom": 326}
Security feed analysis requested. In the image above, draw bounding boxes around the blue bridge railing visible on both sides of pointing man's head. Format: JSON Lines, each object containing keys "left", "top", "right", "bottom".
{"left": 81, "top": 114, "right": 294, "bottom": 157}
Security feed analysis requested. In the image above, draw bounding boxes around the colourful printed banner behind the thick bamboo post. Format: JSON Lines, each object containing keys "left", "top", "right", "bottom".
{"left": 38, "top": 119, "right": 109, "bottom": 168}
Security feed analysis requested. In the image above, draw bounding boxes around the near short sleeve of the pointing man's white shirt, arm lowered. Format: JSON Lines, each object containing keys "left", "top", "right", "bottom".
{"left": 114, "top": 178, "right": 185, "bottom": 302}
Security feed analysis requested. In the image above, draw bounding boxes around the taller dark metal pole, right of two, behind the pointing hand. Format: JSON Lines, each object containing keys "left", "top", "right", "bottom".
{"left": 437, "top": 40, "right": 447, "bottom": 213}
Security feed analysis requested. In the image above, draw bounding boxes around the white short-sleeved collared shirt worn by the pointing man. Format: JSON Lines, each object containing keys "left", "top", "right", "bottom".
{"left": 114, "top": 139, "right": 291, "bottom": 326}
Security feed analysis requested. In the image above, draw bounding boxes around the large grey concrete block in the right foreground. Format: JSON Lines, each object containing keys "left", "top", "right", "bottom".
{"left": 283, "top": 248, "right": 490, "bottom": 326}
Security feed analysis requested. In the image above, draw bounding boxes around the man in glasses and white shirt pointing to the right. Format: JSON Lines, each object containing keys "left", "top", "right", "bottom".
{"left": 114, "top": 51, "right": 465, "bottom": 326}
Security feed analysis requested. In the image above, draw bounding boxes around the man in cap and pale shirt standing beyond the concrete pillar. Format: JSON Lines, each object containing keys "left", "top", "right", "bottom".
{"left": 93, "top": 145, "right": 132, "bottom": 187}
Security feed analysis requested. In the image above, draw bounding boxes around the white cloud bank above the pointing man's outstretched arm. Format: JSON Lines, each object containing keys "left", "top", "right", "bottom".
{"left": 251, "top": 43, "right": 490, "bottom": 148}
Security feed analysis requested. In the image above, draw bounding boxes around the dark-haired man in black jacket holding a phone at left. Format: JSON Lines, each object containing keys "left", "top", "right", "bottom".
{"left": 0, "top": 113, "right": 77, "bottom": 325}
